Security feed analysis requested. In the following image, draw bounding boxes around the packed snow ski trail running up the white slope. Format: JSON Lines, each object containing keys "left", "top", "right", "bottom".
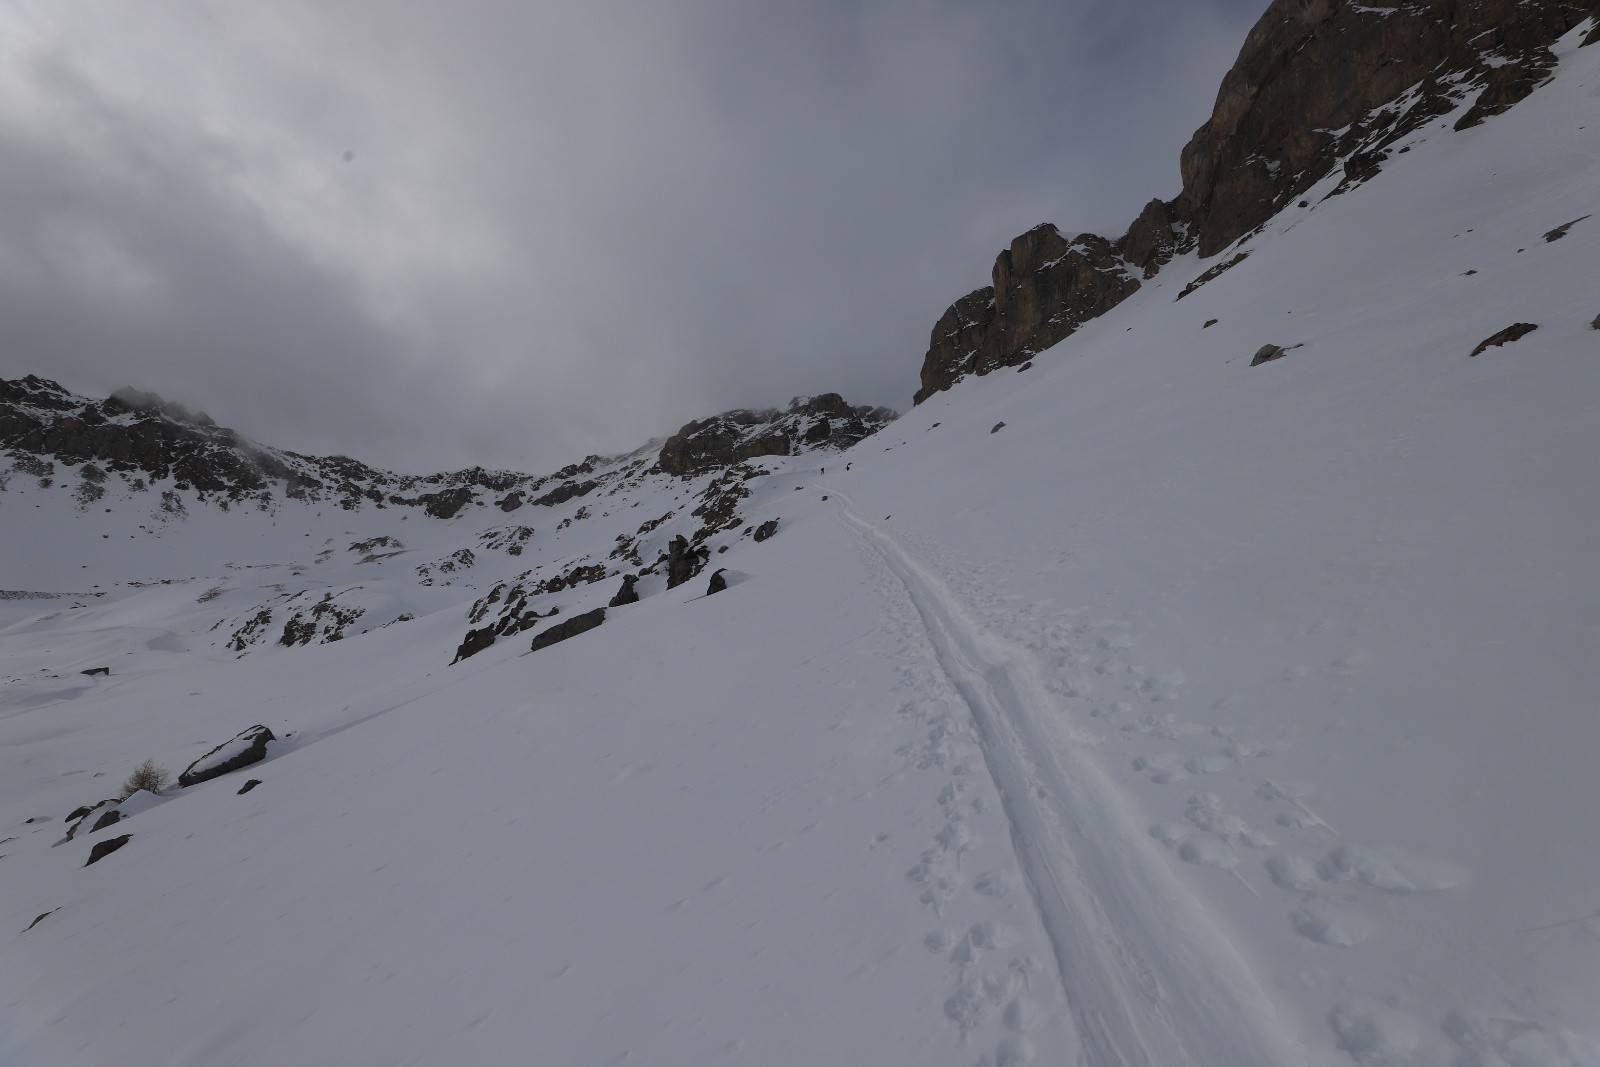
{"left": 840, "top": 506, "right": 1314, "bottom": 1067}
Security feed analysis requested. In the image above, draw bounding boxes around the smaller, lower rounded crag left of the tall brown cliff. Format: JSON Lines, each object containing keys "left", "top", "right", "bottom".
{"left": 915, "top": 225, "right": 1139, "bottom": 403}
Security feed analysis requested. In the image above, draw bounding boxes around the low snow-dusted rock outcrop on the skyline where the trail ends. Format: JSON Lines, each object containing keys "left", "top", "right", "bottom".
{"left": 656, "top": 394, "right": 894, "bottom": 478}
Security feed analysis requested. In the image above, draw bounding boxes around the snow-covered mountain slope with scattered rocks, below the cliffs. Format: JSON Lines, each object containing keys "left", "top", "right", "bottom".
{"left": 9, "top": 20, "right": 1600, "bottom": 1067}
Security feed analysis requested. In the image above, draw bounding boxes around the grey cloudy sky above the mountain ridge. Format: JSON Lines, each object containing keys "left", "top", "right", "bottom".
{"left": 0, "top": 0, "right": 1266, "bottom": 470}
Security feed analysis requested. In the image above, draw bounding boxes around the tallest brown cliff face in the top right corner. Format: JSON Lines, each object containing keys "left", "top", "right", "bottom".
{"left": 1179, "top": 0, "right": 1594, "bottom": 256}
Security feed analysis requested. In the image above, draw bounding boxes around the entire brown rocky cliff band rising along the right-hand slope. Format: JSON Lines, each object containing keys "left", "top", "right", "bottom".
{"left": 915, "top": 0, "right": 1600, "bottom": 403}
